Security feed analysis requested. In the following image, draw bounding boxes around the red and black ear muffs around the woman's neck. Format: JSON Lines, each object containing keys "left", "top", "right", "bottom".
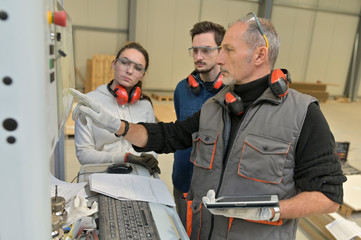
{"left": 107, "top": 80, "right": 142, "bottom": 105}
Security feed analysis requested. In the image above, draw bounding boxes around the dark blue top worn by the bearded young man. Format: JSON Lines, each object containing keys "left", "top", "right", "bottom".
{"left": 172, "top": 74, "right": 221, "bottom": 193}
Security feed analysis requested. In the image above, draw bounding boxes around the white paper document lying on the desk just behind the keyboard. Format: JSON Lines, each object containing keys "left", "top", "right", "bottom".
{"left": 89, "top": 173, "right": 175, "bottom": 207}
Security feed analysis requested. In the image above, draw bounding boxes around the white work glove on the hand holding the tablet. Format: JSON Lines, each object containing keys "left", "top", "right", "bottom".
{"left": 202, "top": 190, "right": 273, "bottom": 221}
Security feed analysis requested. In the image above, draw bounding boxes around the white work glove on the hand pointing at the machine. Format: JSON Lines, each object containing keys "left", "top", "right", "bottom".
{"left": 70, "top": 88, "right": 122, "bottom": 133}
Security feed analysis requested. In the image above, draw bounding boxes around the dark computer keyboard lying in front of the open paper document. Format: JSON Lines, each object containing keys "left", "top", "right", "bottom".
{"left": 98, "top": 194, "right": 160, "bottom": 240}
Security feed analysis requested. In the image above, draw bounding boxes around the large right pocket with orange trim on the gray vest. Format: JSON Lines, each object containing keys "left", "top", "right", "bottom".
{"left": 238, "top": 134, "right": 290, "bottom": 184}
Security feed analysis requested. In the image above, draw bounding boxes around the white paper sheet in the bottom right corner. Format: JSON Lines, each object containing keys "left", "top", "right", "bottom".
{"left": 326, "top": 219, "right": 361, "bottom": 240}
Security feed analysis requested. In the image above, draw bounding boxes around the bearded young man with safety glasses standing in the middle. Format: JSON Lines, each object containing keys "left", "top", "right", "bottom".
{"left": 172, "top": 21, "right": 226, "bottom": 223}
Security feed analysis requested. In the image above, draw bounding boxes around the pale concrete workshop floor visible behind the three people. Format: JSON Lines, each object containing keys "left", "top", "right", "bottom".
{"left": 65, "top": 97, "right": 361, "bottom": 240}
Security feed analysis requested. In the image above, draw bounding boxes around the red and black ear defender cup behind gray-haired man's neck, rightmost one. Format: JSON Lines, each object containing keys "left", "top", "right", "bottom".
{"left": 268, "top": 69, "right": 291, "bottom": 98}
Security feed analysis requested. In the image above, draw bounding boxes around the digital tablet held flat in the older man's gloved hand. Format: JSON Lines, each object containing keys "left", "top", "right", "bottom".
{"left": 206, "top": 195, "right": 278, "bottom": 208}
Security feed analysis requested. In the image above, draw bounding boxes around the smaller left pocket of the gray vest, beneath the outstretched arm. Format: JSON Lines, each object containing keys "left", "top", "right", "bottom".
{"left": 190, "top": 130, "right": 219, "bottom": 169}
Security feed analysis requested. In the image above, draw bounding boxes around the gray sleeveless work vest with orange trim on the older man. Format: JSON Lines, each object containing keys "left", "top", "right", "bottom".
{"left": 187, "top": 87, "right": 317, "bottom": 240}
